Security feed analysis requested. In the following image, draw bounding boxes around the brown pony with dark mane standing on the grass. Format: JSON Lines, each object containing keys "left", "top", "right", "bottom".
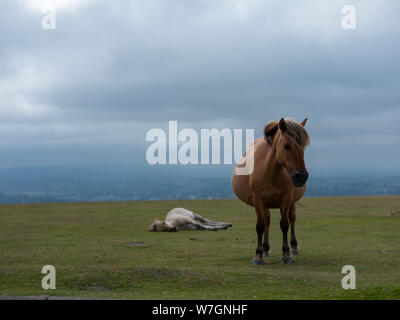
{"left": 232, "top": 118, "right": 309, "bottom": 265}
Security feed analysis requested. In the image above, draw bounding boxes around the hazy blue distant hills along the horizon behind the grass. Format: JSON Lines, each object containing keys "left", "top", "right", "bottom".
{"left": 0, "top": 167, "right": 400, "bottom": 203}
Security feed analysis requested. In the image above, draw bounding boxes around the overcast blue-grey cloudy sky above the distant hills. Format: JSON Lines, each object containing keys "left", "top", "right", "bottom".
{"left": 0, "top": 0, "right": 400, "bottom": 172}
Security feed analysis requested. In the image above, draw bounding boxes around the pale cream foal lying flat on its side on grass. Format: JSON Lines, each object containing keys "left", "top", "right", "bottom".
{"left": 149, "top": 208, "right": 232, "bottom": 231}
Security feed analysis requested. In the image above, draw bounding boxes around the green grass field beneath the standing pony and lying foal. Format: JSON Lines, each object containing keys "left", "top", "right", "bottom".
{"left": 0, "top": 197, "right": 400, "bottom": 299}
